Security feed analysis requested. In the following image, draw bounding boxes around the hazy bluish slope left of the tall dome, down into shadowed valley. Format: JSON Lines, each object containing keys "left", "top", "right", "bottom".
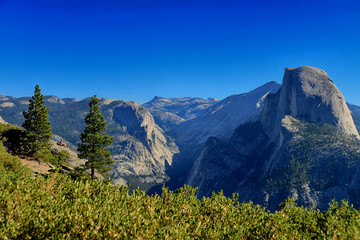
{"left": 163, "top": 82, "right": 280, "bottom": 188}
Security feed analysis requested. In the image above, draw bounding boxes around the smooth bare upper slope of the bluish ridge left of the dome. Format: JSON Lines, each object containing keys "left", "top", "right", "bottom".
{"left": 170, "top": 82, "right": 280, "bottom": 145}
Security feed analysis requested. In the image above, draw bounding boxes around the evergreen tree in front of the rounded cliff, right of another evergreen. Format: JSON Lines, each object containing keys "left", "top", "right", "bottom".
{"left": 78, "top": 95, "right": 114, "bottom": 179}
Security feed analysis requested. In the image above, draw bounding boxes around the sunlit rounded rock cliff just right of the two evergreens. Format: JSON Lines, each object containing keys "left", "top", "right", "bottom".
{"left": 102, "top": 101, "right": 178, "bottom": 187}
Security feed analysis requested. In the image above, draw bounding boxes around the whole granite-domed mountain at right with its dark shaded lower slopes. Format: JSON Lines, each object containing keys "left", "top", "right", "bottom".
{"left": 187, "top": 67, "right": 360, "bottom": 209}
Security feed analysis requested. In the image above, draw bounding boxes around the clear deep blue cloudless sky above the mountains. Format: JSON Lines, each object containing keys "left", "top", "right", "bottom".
{"left": 0, "top": 0, "right": 360, "bottom": 105}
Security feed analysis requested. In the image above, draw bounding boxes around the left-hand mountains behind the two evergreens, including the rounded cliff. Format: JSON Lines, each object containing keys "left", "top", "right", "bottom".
{"left": 0, "top": 96, "right": 178, "bottom": 189}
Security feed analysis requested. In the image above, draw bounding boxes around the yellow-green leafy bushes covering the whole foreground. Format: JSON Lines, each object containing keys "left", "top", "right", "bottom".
{"left": 0, "top": 168, "right": 360, "bottom": 239}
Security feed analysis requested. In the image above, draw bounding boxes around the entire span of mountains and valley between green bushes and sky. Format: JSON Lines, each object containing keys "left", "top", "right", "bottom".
{"left": 0, "top": 67, "right": 360, "bottom": 210}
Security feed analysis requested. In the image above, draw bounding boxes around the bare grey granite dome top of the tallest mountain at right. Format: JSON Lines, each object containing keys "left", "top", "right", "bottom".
{"left": 261, "top": 67, "right": 359, "bottom": 142}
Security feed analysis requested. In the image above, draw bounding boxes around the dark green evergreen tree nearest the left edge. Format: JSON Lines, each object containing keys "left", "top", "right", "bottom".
{"left": 22, "top": 85, "right": 51, "bottom": 156}
